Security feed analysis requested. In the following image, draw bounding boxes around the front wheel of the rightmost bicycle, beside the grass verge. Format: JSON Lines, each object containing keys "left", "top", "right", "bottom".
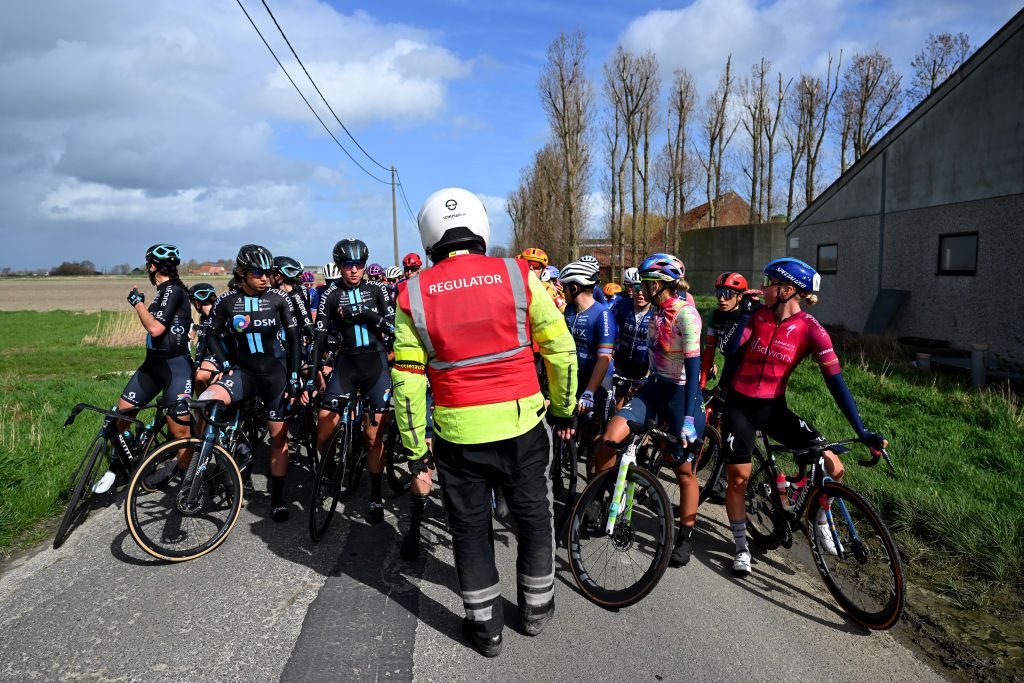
{"left": 807, "top": 481, "right": 906, "bottom": 630}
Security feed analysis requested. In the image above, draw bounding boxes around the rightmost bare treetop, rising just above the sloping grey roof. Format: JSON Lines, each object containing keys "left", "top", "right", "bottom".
{"left": 841, "top": 51, "right": 903, "bottom": 161}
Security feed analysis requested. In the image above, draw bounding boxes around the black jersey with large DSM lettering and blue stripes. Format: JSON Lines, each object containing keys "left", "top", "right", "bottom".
{"left": 209, "top": 289, "right": 299, "bottom": 373}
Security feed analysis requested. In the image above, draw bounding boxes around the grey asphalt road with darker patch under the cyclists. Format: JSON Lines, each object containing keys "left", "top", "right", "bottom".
{"left": 0, "top": 448, "right": 941, "bottom": 681}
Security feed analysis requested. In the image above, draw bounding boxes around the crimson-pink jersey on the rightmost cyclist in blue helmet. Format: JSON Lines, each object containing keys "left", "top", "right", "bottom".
{"left": 732, "top": 306, "right": 842, "bottom": 398}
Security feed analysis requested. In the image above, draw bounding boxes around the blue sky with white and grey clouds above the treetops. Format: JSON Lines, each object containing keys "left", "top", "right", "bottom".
{"left": 0, "top": 0, "right": 1020, "bottom": 268}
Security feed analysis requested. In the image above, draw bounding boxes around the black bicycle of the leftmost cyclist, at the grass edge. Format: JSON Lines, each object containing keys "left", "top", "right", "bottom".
{"left": 53, "top": 403, "right": 170, "bottom": 550}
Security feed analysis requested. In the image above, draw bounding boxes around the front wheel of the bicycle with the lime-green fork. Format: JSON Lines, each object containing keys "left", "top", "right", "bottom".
{"left": 568, "top": 466, "right": 674, "bottom": 607}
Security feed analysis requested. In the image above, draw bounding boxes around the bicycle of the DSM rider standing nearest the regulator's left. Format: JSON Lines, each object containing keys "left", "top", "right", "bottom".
{"left": 309, "top": 391, "right": 378, "bottom": 542}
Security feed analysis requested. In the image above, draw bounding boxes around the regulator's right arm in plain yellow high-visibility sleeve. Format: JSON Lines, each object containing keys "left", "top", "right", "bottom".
{"left": 528, "top": 278, "right": 579, "bottom": 418}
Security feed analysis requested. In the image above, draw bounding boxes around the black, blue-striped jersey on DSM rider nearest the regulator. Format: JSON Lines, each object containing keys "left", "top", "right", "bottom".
{"left": 313, "top": 281, "right": 394, "bottom": 359}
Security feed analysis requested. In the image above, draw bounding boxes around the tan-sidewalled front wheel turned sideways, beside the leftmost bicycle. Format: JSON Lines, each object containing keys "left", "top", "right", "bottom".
{"left": 125, "top": 436, "right": 243, "bottom": 562}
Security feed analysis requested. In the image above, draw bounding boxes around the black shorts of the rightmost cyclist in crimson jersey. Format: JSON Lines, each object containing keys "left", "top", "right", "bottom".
{"left": 722, "top": 390, "right": 824, "bottom": 465}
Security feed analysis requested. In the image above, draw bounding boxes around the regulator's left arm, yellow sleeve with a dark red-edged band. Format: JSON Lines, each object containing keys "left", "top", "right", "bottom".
{"left": 391, "top": 308, "right": 427, "bottom": 457}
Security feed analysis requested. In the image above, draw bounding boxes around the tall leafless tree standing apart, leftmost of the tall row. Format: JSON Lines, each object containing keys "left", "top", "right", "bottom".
{"left": 539, "top": 32, "right": 594, "bottom": 258}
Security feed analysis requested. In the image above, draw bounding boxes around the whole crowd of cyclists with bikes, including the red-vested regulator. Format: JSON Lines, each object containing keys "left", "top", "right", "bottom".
{"left": 54, "top": 187, "right": 904, "bottom": 656}
